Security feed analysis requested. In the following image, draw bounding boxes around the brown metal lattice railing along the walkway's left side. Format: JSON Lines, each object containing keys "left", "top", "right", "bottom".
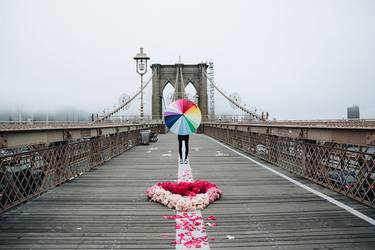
{"left": 0, "top": 125, "right": 159, "bottom": 213}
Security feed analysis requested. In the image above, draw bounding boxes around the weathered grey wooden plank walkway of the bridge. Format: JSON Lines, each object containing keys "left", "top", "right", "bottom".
{"left": 0, "top": 135, "right": 375, "bottom": 250}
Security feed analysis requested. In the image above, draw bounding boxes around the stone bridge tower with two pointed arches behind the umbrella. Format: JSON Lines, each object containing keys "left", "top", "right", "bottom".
{"left": 151, "top": 63, "right": 208, "bottom": 120}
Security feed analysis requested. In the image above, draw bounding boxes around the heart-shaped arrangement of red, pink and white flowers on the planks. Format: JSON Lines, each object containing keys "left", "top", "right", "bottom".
{"left": 146, "top": 181, "right": 223, "bottom": 211}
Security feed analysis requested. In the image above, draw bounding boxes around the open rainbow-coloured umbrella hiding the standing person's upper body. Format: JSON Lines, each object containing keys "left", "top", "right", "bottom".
{"left": 164, "top": 99, "right": 202, "bottom": 135}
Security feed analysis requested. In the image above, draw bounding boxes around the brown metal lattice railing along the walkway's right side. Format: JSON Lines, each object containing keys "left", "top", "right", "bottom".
{"left": 203, "top": 123, "right": 375, "bottom": 207}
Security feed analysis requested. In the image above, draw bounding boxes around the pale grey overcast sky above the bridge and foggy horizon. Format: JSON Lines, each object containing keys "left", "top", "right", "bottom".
{"left": 0, "top": 0, "right": 375, "bottom": 119}
